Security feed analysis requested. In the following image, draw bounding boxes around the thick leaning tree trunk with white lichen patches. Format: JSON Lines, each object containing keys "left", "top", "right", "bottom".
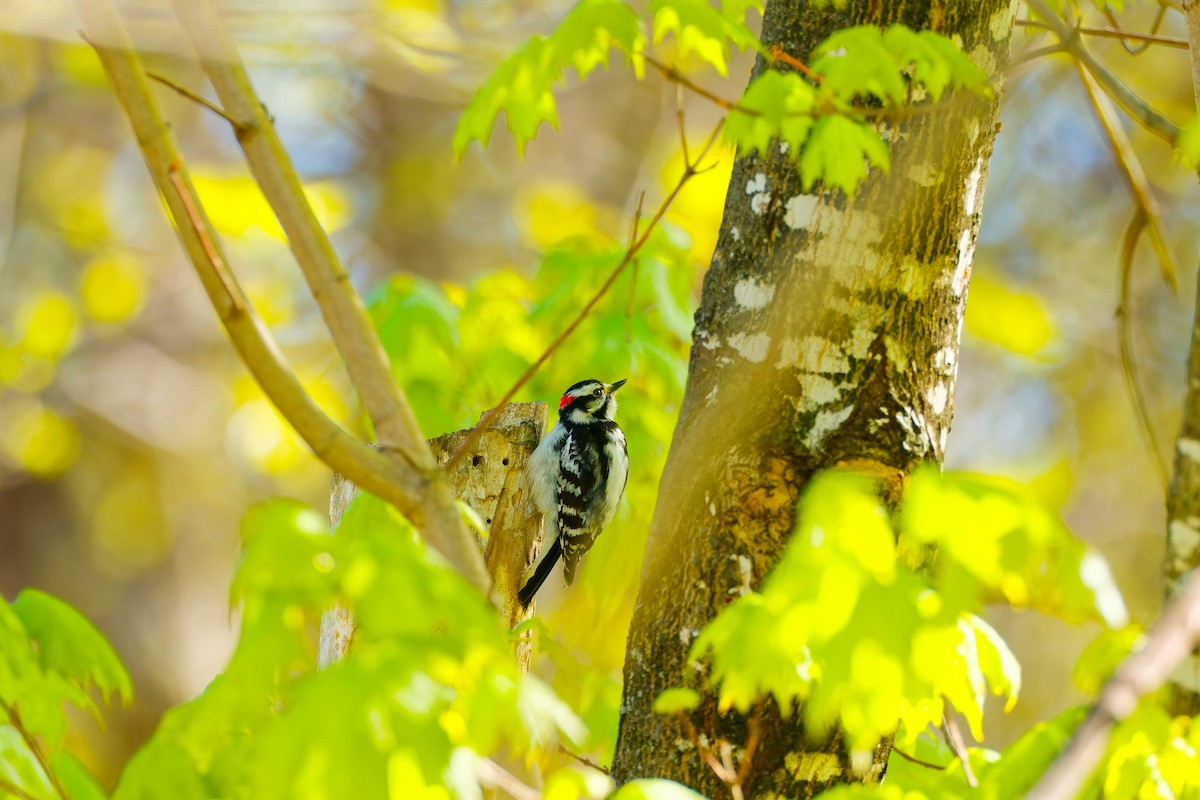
{"left": 613, "top": 0, "right": 1016, "bottom": 796}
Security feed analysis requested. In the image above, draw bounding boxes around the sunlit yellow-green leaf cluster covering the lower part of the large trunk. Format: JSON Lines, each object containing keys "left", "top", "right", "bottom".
{"left": 691, "top": 469, "right": 1127, "bottom": 750}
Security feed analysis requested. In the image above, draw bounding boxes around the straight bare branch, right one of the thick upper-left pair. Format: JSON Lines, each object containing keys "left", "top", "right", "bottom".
{"left": 172, "top": 0, "right": 436, "bottom": 474}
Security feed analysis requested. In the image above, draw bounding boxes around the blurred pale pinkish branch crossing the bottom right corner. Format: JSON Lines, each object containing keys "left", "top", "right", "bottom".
{"left": 1026, "top": 571, "right": 1200, "bottom": 800}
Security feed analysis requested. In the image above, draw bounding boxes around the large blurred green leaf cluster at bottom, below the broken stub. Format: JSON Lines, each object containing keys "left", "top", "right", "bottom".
{"left": 115, "top": 494, "right": 586, "bottom": 799}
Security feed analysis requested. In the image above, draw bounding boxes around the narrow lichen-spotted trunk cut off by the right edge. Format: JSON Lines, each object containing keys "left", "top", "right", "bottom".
{"left": 1163, "top": 0, "right": 1200, "bottom": 716}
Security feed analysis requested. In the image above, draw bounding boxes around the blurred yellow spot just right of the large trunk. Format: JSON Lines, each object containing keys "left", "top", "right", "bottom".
{"left": 966, "top": 272, "right": 1054, "bottom": 356}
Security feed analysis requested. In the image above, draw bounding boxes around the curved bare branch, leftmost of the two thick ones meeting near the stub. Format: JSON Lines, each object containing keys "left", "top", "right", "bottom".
{"left": 76, "top": 0, "right": 488, "bottom": 591}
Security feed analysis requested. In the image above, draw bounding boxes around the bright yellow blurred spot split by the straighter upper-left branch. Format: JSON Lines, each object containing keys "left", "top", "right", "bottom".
{"left": 192, "top": 167, "right": 352, "bottom": 239}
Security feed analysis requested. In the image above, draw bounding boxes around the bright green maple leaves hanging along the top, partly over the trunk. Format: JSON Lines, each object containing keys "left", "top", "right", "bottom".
{"left": 454, "top": 0, "right": 990, "bottom": 193}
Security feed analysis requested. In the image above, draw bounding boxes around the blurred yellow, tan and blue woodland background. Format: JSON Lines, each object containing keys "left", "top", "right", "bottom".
{"left": 0, "top": 0, "right": 1200, "bottom": 782}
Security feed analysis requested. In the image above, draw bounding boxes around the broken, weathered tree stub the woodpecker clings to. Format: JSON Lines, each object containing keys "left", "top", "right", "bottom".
{"left": 317, "top": 403, "right": 546, "bottom": 668}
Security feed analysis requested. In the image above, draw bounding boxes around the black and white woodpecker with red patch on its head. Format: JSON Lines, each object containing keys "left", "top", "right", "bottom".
{"left": 517, "top": 380, "right": 629, "bottom": 607}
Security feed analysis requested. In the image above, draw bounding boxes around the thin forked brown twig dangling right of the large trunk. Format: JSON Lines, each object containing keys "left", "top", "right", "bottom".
{"left": 1075, "top": 61, "right": 1176, "bottom": 492}
